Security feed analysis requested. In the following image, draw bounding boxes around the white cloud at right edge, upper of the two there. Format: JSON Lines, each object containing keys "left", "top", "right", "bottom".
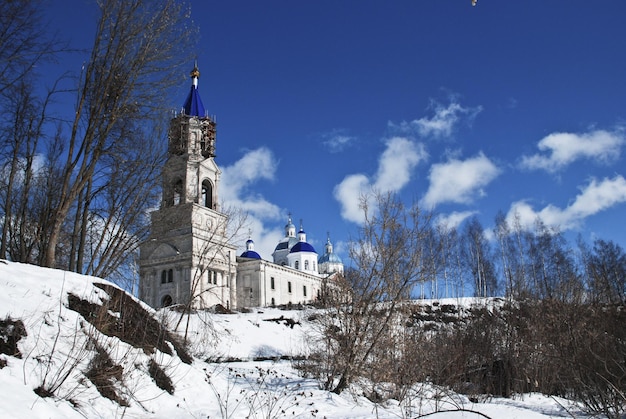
{"left": 521, "top": 130, "right": 625, "bottom": 173}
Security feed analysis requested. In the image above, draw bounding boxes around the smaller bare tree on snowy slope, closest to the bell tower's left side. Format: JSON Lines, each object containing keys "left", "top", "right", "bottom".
{"left": 67, "top": 120, "right": 165, "bottom": 277}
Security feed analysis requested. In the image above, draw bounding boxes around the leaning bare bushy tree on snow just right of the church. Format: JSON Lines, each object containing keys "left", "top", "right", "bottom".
{"left": 302, "top": 194, "right": 431, "bottom": 393}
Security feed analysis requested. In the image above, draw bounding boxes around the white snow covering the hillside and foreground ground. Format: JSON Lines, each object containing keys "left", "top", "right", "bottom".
{"left": 0, "top": 261, "right": 580, "bottom": 419}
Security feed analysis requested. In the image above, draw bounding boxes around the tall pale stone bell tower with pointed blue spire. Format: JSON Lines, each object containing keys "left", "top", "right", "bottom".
{"left": 139, "top": 65, "right": 237, "bottom": 308}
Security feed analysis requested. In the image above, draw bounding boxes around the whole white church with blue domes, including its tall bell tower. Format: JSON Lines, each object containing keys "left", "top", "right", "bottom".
{"left": 139, "top": 66, "right": 343, "bottom": 309}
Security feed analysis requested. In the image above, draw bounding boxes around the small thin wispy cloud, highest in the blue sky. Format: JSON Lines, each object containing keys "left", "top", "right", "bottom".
{"left": 389, "top": 101, "right": 482, "bottom": 138}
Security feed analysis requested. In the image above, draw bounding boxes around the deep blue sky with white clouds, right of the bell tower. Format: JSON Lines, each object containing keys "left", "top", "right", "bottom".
{"left": 46, "top": 0, "right": 626, "bottom": 259}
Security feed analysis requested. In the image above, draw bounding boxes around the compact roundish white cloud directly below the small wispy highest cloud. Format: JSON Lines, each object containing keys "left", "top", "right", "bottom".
{"left": 422, "top": 153, "right": 500, "bottom": 208}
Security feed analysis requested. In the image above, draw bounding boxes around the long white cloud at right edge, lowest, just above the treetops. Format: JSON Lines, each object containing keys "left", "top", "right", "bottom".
{"left": 506, "top": 175, "right": 626, "bottom": 230}
